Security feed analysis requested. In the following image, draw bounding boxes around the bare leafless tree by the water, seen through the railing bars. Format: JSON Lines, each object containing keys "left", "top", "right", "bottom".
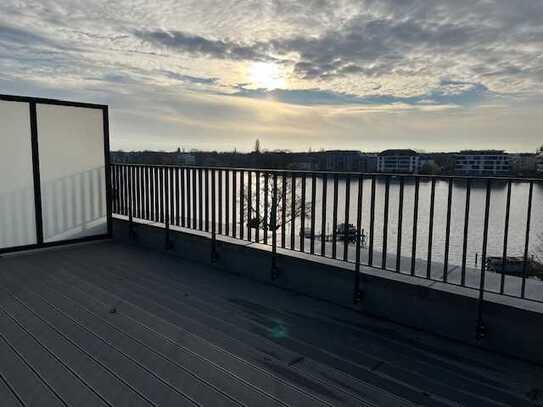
{"left": 244, "top": 172, "right": 311, "bottom": 239}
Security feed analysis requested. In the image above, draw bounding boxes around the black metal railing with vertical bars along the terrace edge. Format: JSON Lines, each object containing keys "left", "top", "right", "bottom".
{"left": 112, "top": 164, "right": 543, "bottom": 336}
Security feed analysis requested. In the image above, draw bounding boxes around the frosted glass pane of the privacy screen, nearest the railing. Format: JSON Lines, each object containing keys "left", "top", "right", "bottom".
{"left": 37, "top": 105, "right": 107, "bottom": 242}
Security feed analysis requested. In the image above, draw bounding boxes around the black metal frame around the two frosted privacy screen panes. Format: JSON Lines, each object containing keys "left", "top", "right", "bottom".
{"left": 0, "top": 94, "right": 113, "bottom": 255}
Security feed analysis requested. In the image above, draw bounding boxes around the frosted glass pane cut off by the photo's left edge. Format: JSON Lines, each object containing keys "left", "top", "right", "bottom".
{"left": 0, "top": 101, "right": 36, "bottom": 249}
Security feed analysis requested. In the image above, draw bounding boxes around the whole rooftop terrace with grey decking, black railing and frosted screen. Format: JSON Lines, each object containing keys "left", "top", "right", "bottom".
{"left": 0, "top": 95, "right": 543, "bottom": 407}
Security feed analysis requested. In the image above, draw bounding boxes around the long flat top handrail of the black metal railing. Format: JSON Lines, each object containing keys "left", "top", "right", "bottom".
{"left": 111, "top": 162, "right": 543, "bottom": 183}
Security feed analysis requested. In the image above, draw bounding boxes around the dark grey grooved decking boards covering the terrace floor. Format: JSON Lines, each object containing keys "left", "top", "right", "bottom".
{"left": 0, "top": 242, "right": 543, "bottom": 406}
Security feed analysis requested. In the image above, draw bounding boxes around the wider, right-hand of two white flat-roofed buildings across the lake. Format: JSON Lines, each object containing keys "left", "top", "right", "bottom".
{"left": 455, "top": 150, "right": 512, "bottom": 177}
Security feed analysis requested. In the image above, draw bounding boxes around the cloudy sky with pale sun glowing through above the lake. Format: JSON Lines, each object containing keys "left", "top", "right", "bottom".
{"left": 0, "top": 0, "right": 543, "bottom": 152}
